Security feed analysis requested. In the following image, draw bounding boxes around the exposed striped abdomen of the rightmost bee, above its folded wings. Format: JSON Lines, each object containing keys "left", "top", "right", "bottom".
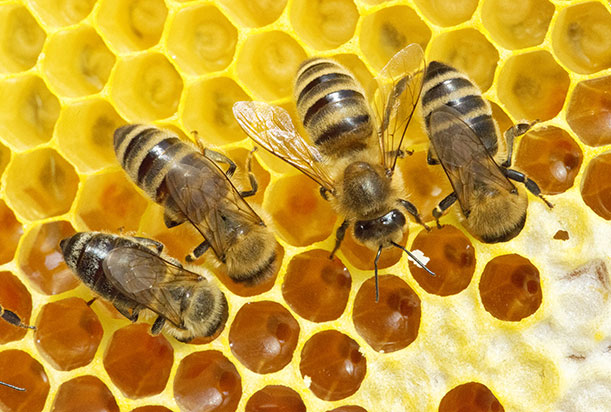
{"left": 421, "top": 61, "right": 499, "bottom": 155}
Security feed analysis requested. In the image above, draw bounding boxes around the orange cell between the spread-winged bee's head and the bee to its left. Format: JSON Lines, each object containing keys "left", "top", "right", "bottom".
{"left": 265, "top": 174, "right": 336, "bottom": 246}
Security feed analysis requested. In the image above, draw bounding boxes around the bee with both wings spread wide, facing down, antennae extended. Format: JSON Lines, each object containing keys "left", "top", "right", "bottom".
{"left": 233, "top": 44, "right": 434, "bottom": 300}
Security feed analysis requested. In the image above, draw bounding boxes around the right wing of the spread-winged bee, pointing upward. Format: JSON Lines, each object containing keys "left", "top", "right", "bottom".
{"left": 374, "top": 43, "right": 426, "bottom": 171}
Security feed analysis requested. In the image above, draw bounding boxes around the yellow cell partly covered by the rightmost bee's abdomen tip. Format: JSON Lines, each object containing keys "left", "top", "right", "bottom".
{"left": 429, "top": 29, "right": 499, "bottom": 91}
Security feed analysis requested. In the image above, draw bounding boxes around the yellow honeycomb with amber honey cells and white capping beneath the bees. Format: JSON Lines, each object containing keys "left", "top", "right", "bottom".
{"left": 0, "top": 0, "right": 611, "bottom": 412}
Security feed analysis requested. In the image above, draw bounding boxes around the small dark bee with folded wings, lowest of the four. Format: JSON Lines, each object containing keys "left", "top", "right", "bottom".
{"left": 60, "top": 232, "right": 228, "bottom": 342}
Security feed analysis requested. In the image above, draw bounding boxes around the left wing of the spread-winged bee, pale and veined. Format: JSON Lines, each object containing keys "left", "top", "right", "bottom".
{"left": 233, "top": 101, "right": 335, "bottom": 192}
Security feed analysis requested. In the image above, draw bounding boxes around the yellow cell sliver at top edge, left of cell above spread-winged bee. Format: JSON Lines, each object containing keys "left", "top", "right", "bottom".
{"left": 218, "top": 0, "right": 287, "bottom": 27}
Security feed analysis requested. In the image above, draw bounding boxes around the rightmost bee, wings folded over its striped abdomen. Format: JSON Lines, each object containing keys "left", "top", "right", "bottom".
{"left": 422, "top": 61, "right": 553, "bottom": 243}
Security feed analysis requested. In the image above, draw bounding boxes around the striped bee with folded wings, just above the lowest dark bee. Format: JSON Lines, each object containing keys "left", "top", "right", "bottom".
{"left": 114, "top": 125, "right": 279, "bottom": 285}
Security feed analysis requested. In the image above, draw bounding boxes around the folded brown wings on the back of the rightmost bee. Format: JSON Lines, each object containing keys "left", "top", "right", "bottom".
{"left": 429, "top": 106, "right": 515, "bottom": 215}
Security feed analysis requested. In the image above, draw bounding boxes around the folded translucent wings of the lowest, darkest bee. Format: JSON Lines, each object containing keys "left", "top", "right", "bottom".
{"left": 102, "top": 247, "right": 203, "bottom": 325}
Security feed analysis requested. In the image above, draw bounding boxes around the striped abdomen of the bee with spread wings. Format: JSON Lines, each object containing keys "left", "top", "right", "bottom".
{"left": 295, "top": 59, "right": 374, "bottom": 156}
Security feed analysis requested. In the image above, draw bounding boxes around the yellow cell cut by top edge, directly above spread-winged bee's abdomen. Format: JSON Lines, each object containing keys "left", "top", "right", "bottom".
{"left": 290, "top": 0, "right": 359, "bottom": 50}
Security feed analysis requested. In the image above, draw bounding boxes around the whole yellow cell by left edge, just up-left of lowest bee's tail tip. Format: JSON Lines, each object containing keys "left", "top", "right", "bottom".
{"left": 6, "top": 148, "right": 79, "bottom": 220}
